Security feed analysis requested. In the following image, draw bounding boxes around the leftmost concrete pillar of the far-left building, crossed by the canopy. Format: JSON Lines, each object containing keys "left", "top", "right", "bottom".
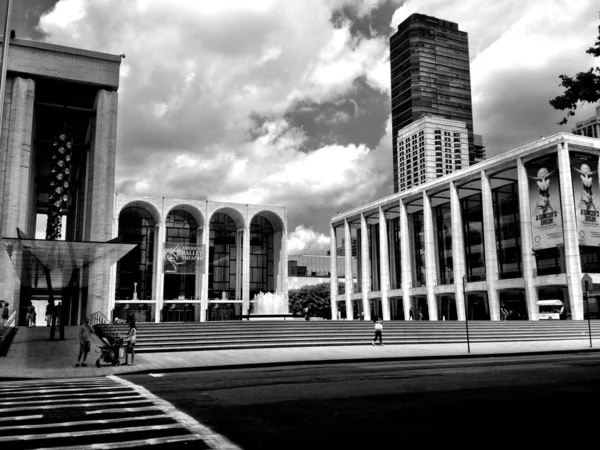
{"left": 0, "top": 77, "right": 36, "bottom": 324}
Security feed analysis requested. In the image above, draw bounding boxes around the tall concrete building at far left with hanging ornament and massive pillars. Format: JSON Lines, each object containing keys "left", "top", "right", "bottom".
{"left": 0, "top": 39, "right": 125, "bottom": 324}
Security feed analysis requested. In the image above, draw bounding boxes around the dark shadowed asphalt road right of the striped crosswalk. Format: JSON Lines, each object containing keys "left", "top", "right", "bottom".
{"left": 126, "top": 353, "right": 600, "bottom": 450}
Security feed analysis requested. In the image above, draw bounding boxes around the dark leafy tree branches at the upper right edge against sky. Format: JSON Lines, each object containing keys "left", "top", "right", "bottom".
{"left": 550, "top": 26, "right": 600, "bottom": 125}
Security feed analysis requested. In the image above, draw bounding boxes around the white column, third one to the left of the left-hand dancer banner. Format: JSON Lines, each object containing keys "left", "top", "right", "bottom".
{"left": 449, "top": 181, "right": 467, "bottom": 320}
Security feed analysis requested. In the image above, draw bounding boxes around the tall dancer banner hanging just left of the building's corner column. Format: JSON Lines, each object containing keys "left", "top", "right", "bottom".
{"left": 525, "top": 154, "right": 563, "bottom": 250}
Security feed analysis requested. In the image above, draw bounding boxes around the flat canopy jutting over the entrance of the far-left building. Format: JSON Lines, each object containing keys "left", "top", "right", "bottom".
{"left": 2, "top": 237, "right": 136, "bottom": 289}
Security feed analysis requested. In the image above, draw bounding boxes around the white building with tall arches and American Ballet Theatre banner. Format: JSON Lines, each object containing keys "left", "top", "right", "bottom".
{"left": 110, "top": 194, "right": 288, "bottom": 322}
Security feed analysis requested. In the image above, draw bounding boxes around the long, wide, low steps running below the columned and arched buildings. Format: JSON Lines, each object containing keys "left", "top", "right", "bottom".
{"left": 115, "top": 320, "right": 600, "bottom": 353}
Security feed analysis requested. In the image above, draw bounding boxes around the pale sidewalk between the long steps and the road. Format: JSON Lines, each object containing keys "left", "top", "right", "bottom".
{"left": 0, "top": 327, "right": 600, "bottom": 381}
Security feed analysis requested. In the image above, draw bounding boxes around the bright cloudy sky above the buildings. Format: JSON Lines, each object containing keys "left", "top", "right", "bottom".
{"left": 5, "top": 0, "right": 600, "bottom": 255}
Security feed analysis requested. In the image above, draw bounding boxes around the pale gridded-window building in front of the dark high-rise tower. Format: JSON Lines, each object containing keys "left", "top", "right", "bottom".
{"left": 397, "top": 117, "right": 469, "bottom": 191}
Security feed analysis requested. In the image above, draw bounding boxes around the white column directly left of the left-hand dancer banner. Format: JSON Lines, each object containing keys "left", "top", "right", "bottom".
{"left": 517, "top": 158, "right": 538, "bottom": 320}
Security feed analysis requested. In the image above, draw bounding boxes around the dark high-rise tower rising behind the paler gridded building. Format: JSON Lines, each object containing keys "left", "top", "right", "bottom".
{"left": 390, "top": 14, "right": 485, "bottom": 192}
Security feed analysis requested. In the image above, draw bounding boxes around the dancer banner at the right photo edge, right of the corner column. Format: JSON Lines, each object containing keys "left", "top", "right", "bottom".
{"left": 569, "top": 152, "right": 600, "bottom": 247}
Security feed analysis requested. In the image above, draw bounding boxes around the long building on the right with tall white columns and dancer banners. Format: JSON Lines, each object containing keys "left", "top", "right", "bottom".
{"left": 331, "top": 133, "right": 600, "bottom": 320}
